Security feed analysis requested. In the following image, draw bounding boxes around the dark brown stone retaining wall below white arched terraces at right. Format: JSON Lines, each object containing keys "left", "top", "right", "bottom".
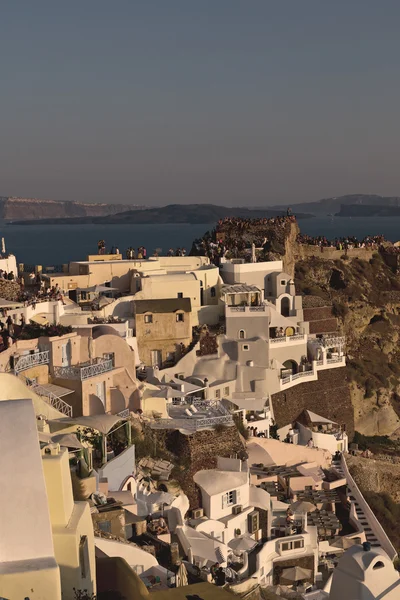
{"left": 272, "top": 367, "right": 354, "bottom": 440}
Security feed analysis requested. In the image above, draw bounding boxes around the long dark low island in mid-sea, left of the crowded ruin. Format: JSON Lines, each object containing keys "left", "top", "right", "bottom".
{"left": 11, "top": 204, "right": 312, "bottom": 225}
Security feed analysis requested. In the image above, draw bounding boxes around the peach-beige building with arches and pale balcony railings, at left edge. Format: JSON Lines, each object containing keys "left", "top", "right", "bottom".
{"left": 0, "top": 325, "right": 137, "bottom": 417}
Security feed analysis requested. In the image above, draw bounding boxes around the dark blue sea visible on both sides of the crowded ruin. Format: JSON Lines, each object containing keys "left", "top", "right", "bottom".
{"left": 0, "top": 217, "right": 400, "bottom": 266}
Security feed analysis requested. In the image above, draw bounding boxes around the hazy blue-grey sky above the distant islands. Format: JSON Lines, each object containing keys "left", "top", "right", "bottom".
{"left": 0, "top": 0, "right": 400, "bottom": 205}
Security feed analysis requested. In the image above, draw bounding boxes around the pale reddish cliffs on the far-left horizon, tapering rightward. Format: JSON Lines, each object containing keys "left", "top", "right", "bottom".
{"left": 0, "top": 196, "right": 142, "bottom": 221}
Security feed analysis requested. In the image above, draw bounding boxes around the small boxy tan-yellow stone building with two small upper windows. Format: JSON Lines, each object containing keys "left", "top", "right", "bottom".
{"left": 135, "top": 298, "right": 192, "bottom": 367}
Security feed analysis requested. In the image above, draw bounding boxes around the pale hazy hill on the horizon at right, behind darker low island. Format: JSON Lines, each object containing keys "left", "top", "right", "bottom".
{"left": 268, "top": 194, "right": 400, "bottom": 217}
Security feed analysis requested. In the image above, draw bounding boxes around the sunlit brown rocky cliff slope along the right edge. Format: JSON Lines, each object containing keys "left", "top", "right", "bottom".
{"left": 295, "top": 252, "right": 400, "bottom": 437}
